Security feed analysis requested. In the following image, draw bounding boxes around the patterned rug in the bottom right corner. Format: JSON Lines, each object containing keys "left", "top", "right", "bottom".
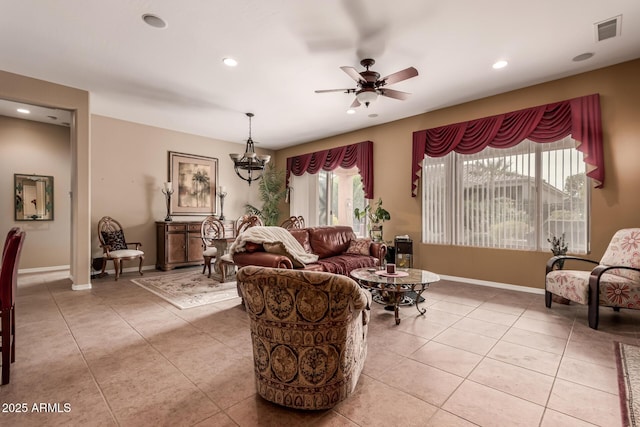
{"left": 614, "top": 342, "right": 640, "bottom": 427}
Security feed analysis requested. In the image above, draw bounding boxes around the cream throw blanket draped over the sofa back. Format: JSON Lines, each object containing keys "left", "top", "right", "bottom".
{"left": 229, "top": 226, "right": 318, "bottom": 265}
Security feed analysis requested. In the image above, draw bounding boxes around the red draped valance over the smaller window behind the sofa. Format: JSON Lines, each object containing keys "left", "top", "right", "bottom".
{"left": 286, "top": 141, "right": 373, "bottom": 199}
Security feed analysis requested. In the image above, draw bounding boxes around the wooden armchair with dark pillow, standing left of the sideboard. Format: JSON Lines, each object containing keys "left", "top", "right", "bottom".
{"left": 98, "top": 216, "right": 144, "bottom": 280}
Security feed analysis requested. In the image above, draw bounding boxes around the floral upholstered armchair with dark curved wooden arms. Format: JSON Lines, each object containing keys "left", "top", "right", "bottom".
{"left": 545, "top": 228, "right": 640, "bottom": 329}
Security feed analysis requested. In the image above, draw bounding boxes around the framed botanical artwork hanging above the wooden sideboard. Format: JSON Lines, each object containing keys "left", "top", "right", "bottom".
{"left": 169, "top": 151, "right": 218, "bottom": 215}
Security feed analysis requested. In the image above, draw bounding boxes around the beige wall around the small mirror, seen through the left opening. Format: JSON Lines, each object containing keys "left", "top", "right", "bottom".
{"left": 0, "top": 116, "right": 71, "bottom": 269}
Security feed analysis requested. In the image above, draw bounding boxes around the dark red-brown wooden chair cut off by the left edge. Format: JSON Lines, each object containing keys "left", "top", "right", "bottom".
{"left": 0, "top": 229, "right": 26, "bottom": 384}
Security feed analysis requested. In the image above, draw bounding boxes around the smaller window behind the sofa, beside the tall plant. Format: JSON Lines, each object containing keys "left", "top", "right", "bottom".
{"left": 290, "top": 168, "right": 366, "bottom": 236}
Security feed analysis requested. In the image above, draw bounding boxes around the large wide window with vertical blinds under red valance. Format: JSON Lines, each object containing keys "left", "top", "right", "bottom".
{"left": 422, "top": 137, "right": 589, "bottom": 253}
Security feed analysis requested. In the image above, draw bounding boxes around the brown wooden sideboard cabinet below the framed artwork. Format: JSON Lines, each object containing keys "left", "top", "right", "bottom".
{"left": 156, "top": 221, "right": 204, "bottom": 271}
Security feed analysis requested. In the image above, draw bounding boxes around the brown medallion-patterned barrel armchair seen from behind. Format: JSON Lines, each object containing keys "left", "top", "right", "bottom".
{"left": 237, "top": 266, "right": 371, "bottom": 409}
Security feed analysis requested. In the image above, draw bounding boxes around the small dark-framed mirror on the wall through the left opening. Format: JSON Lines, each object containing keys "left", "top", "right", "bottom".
{"left": 13, "top": 174, "right": 53, "bottom": 221}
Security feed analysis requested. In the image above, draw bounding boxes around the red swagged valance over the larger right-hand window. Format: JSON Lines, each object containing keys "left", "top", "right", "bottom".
{"left": 411, "top": 94, "right": 604, "bottom": 197}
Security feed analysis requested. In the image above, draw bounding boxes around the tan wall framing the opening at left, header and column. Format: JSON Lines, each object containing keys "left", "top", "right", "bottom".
{"left": 0, "top": 71, "right": 91, "bottom": 289}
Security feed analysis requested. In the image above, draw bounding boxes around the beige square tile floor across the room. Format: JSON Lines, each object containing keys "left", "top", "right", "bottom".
{"left": 0, "top": 271, "right": 640, "bottom": 427}
